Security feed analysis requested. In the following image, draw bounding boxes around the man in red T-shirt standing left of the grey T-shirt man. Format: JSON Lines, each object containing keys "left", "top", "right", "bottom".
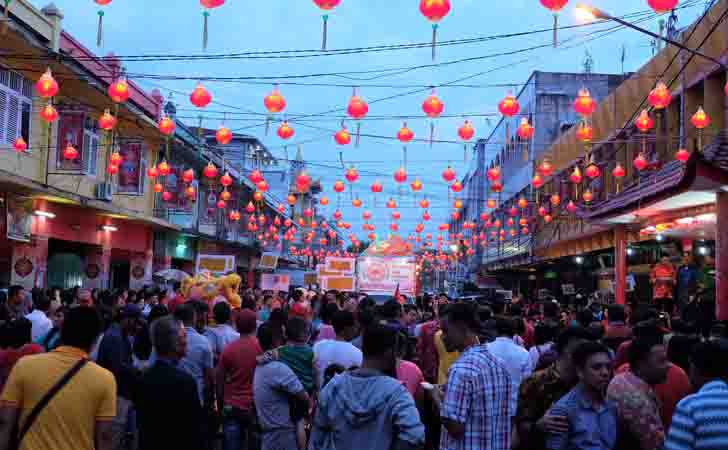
{"left": 216, "top": 309, "right": 263, "bottom": 450}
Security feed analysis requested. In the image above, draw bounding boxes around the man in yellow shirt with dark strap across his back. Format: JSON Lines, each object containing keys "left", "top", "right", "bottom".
{"left": 0, "top": 307, "right": 116, "bottom": 450}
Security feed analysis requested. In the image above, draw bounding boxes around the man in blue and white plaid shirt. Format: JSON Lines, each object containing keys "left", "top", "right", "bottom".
{"left": 432, "top": 303, "right": 516, "bottom": 450}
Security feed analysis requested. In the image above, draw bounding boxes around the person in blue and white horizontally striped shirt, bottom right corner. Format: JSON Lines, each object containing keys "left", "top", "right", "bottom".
{"left": 665, "top": 339, "right": 728, "bottom": 450}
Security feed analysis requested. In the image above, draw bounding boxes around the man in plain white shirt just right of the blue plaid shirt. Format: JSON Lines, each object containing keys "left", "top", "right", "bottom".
{"left": 488, "top": 316, "right": 533, "bottom": 411}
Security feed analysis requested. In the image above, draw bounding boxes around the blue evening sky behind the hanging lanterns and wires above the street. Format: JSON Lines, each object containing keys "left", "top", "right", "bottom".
{"left": 32, "top": 0, "right": 704, "bottom": 243}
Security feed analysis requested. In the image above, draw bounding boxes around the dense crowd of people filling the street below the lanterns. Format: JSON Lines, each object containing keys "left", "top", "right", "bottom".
{"left": 0, "top": 286, "right": 728, "bottom": 450}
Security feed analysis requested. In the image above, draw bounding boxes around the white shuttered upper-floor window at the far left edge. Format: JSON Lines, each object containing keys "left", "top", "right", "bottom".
{"left": 0, "top": 67, "right": 33, "bottom": 147}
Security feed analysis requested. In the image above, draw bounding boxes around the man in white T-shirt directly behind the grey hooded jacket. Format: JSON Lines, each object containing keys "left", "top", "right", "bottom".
{"left": 313, "top": 311, "right": 362, "bottom": 388}
